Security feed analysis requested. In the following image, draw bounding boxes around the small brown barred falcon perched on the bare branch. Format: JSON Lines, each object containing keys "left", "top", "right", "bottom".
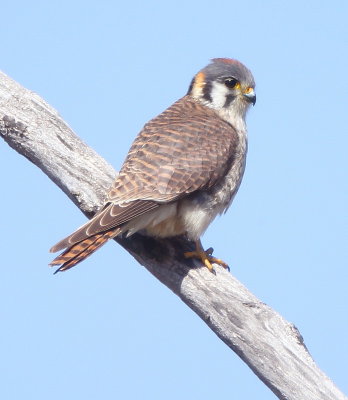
{"left": 50, "top": 58, "right": 256, "bottom": 272}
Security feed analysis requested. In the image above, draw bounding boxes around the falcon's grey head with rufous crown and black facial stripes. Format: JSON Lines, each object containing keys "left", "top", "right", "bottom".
{"left": 188, "top": 58, "right": 256, "bottom": 122}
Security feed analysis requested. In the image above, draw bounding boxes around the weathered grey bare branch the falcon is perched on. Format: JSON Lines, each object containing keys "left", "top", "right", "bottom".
{"left": 0, "top": 73, "right": 347, "bottom": 400}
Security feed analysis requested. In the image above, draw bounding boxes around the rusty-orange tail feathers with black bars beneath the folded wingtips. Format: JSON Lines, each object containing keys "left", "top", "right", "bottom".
{"left": 49, "top": 229, "right": 117, "bottom": 274}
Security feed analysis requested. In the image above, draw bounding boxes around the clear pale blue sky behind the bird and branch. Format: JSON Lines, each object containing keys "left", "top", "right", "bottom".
{"left": 0, "top": 0, "right": 348, "bottom": 400}
